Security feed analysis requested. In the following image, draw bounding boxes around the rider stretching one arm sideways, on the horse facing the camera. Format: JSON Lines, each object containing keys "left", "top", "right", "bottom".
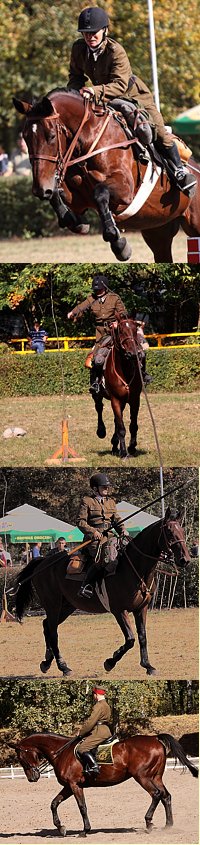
{"left": 67, "top": 274, "right": 151, "bottom": 394}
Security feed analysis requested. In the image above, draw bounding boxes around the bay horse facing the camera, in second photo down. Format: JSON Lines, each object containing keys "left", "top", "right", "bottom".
{"left": 91, "top": 318, "right": 142, "bottom": 458}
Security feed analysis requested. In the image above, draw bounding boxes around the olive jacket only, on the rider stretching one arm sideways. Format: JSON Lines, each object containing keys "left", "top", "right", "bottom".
{"left": 71, "top": 291, "right": 127, "bottom": 341}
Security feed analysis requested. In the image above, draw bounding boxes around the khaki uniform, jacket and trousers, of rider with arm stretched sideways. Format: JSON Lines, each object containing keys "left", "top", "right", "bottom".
{"left": 71, "top": 291, "right": 127, "bottom": 364}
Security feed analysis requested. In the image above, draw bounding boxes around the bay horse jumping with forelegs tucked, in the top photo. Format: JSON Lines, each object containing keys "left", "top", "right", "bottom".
{"left": 13, "top": 88, "right": 200, "bottom": 262}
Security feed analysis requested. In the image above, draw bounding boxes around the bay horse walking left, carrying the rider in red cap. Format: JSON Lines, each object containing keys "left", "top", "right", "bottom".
{"left": 9, "top": 733, "right": 198, "bottom": 836}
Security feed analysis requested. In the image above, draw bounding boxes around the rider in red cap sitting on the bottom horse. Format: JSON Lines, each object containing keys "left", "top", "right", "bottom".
{"left": 76, "top": 687, "right": 111, "bottom": 775}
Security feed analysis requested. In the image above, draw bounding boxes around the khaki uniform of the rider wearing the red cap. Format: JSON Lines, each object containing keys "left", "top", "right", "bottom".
{"left": 78, "top": 698, "right": 111, "bottom": 754}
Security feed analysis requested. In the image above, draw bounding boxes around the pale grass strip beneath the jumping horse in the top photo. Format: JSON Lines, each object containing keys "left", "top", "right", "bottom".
{"left": 0, "top": 230, "right": 187, "bottom": 264}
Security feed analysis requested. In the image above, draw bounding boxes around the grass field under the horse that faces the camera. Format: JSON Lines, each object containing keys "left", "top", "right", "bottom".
{"left": 0, "top": 392, "right": 200, "bottom": 467}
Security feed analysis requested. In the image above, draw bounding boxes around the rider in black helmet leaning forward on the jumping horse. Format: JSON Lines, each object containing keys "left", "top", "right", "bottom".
{"left": 67, "top": 6, "right": 196, "bottom": 193}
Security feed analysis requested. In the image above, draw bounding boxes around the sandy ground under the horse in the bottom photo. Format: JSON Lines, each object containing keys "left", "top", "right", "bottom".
{"left": 0, "top": 768, "right": 199, "bottom": 845}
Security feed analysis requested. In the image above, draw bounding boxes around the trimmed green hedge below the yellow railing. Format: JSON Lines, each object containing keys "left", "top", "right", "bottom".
{"left": 0, "top": 349, "right": 200, "bottom": 397}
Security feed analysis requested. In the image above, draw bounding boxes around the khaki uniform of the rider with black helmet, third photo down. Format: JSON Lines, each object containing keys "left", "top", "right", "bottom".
{"left": 78, "top": 495, "right": 124, "bottom": 566}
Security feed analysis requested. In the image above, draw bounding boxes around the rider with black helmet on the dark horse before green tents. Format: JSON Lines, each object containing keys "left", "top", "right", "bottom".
{"left": 78, "top": 472, "right": 127, "bottom": 598}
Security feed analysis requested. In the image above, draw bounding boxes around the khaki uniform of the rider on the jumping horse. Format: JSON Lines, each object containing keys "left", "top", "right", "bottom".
{"left": 67, "top": 38, "right": 173, "bottom": 147}
